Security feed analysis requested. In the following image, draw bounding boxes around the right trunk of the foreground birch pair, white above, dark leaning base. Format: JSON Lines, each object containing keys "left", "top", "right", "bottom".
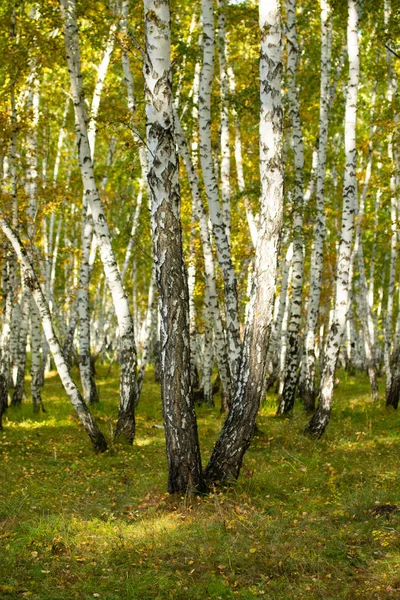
{"left": 205, "top": 0, "right": 283, "bottom": 483}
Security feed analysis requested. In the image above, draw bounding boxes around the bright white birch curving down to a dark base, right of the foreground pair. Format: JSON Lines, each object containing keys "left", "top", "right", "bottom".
{"left": 305, "top": 0, "right": 360, "bottom": 438}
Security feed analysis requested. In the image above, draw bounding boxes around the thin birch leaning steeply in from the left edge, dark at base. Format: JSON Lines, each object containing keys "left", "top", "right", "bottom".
{"left": 0, "top": 217, "right": 107, "bottom": 452}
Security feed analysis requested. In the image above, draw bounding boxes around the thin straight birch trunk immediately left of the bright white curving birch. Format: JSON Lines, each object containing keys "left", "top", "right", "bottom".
{"left": 299, "top": 0, "right": 332, "bottom": 412}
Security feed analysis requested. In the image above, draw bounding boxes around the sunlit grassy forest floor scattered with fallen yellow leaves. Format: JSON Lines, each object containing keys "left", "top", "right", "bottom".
{"left": 0, "top": 368, "right": 400, "bottom": 600}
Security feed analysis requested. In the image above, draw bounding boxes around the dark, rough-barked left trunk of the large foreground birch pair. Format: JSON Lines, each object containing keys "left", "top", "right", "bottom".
{"left": 143, "top": 0, "right": 204, "bottom": 493}
